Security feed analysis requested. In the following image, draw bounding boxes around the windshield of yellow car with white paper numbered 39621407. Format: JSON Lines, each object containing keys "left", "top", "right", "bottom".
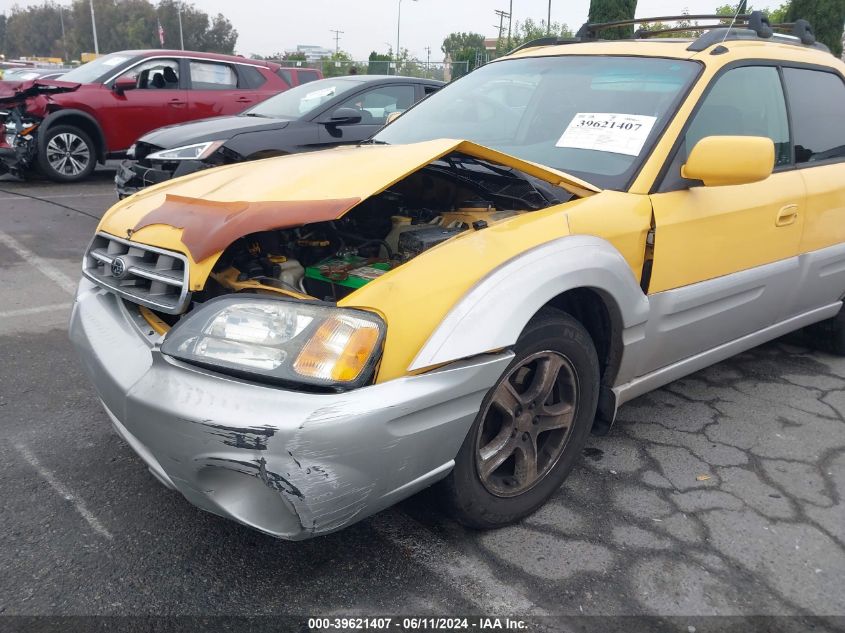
{"left": 375, "top": 55, "right": 700, "bottom": 189}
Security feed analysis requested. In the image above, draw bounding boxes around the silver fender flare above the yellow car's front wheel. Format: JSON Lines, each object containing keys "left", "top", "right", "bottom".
{"left": 408, "top": 235, "right": 649, "bottom": 371}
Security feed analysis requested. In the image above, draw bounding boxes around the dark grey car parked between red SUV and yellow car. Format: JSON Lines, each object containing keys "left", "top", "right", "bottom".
{"left": 115, "top": 75, "right": 443, "bottom": 198}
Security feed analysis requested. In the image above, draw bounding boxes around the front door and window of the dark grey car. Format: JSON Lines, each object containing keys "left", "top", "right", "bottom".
{"left": 317, "top": 84, "right": 415, "bottom": 145}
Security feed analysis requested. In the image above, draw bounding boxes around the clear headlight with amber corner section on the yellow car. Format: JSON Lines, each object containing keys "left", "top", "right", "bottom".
{"left": 161, "top": 295, "right": 385, "bottom": 389}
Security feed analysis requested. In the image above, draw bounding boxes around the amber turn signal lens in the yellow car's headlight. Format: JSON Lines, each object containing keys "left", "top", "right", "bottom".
{"left": 293, "top": 315, "right": 379, "bottom": 382}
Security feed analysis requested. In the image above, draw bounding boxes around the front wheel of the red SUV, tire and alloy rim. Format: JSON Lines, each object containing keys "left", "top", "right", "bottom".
{"left": 38, "top": 125, "right": 97, "bottom": 182}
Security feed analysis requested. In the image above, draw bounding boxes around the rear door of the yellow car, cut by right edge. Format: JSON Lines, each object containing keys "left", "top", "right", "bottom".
{"left": 783, "top": 67, "right": 845, "bottom": 313}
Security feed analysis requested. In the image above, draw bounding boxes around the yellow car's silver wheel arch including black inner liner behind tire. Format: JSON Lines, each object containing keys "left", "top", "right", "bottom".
{"left": 409, "top": 235, "right": 649, "bottom": 428}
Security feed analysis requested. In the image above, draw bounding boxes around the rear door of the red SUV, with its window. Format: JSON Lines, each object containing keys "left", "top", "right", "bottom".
{"left": 188, "top": 59, "right": 249, "bottom": 120}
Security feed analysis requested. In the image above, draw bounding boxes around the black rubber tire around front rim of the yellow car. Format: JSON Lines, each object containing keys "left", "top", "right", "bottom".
{"left": 446, "top": 311, "right": 599, "bottom": 528}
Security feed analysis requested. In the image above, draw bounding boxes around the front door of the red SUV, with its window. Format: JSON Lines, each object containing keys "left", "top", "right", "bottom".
{"left": 97, "top": 58, "right": 188, "bottom": 152}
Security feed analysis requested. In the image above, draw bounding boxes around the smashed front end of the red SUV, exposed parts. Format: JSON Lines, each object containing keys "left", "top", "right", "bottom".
{"left": 0, "top": 80, "right": 79, "bottom": 178}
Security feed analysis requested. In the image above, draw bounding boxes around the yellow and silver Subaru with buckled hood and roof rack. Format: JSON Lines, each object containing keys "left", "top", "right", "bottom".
{"left": 71, "top": 14, "right": 845, "bottom": 539}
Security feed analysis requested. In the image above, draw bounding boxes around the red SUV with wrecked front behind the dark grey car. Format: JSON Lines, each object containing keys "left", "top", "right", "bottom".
{"left": 0, "top": 50, "right": 321, "bottom": 182}
